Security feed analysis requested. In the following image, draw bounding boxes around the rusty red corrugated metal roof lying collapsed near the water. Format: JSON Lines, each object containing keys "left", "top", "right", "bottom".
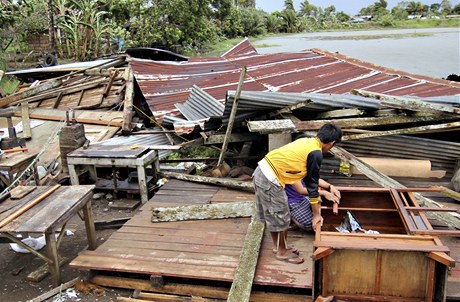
{"left": 130, "top": 41, "right": 460, "bottom": 121}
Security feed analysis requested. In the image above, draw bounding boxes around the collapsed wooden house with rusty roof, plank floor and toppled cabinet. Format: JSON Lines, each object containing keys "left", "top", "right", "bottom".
{"left": 0, "top": 40, "right": 460, "bottom": 301}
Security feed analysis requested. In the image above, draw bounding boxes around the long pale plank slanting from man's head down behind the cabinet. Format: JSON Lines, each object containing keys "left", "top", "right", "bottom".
{"left": 330, "top": 146, "right": 460, "bottom": 229}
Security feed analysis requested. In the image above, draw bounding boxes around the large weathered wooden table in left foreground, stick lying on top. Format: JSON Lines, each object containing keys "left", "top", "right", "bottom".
{"left": 0, "top": 185, "right": 96, "bottom": 286}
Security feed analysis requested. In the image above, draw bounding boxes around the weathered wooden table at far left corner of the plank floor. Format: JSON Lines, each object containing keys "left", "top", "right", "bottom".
{"left": 67, "top": 145, "right": 160, "bottom": 203}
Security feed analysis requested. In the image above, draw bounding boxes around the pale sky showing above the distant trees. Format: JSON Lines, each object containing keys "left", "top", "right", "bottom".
{"left": 256, "top": 0, "right": 460, "bottom": 15}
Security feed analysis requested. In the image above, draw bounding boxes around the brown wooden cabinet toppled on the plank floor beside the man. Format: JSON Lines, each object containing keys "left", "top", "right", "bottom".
{"left": 313, "top": 188, "right": 460, "bottom": 301}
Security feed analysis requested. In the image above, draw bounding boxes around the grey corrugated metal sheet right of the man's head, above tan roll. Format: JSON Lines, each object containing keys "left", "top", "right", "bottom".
{"left": 340, "top": 135, "right": 460, "bottom": 178}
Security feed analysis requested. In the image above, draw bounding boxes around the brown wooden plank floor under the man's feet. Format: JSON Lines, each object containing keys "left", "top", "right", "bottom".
{"left": 70, "top": 180, "right": 460, "bottom": 301}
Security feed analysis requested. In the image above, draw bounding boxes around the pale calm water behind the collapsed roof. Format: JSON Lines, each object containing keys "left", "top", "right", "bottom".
{"left": 252, "top": 28, "right": 460, "bottom": 78}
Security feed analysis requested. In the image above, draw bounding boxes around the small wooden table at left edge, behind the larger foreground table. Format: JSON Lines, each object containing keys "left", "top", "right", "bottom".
{"left": 0, "top": 152, "right": 38, "bottom": 186}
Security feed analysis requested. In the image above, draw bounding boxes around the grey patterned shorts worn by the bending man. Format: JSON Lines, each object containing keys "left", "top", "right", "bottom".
{"left": 253, "top": 167, "right": 291, "bottom": 232}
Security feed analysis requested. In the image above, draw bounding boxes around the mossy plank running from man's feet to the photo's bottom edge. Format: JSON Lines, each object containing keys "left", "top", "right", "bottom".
{"left": 227, "top": 216, "right": 265, "bottom": 302}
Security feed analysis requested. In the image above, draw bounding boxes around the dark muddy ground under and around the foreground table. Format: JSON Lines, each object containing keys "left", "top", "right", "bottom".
{"left": 0, "top": 195, "right": 136, "bottom": 302}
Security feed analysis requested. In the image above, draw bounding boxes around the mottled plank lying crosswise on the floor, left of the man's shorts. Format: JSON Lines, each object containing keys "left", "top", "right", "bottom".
{"left": 151, "top": 202, "right": 255, "bottom": 222}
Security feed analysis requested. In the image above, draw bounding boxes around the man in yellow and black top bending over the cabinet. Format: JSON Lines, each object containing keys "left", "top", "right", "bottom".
{"left": 254, "top": 124, "right": 342, "bottom": 264}
